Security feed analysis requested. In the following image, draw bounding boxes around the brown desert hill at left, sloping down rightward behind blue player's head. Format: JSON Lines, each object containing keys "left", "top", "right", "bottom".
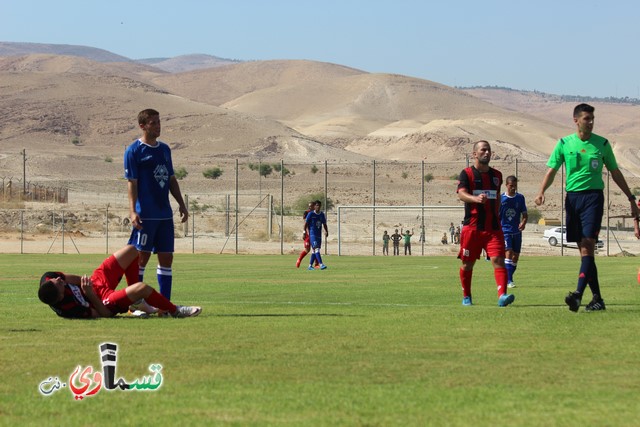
{"left": 0, "top": 55, "right": 380, "bottom": 194}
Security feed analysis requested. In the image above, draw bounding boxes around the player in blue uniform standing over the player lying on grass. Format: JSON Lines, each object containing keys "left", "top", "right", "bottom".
{"left": 124, "top": 109, "right": 189, "bottom": 300}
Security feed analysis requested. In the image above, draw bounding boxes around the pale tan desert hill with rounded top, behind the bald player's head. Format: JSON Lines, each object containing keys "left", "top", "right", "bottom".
{"left": 153, "top": 61, "right": 564, "bottom": 160}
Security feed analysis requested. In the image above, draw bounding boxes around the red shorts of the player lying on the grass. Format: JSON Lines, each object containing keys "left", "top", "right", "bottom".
{"left": 91, "top": 255, "right": 131, "bottom": 314}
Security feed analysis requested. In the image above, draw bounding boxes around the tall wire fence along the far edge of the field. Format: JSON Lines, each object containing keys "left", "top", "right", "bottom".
{"left": 0, "top": 159, "right": 640, "bottom": 255}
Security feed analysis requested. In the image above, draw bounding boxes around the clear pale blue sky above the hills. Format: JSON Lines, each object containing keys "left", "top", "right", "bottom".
{"left": 0, "top": 0, "right": 640, "bottom": 98}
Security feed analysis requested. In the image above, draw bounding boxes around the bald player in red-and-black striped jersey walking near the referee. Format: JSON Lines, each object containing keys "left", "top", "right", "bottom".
{"left": 457, "top": 141, "right": 515, "bottom": 307}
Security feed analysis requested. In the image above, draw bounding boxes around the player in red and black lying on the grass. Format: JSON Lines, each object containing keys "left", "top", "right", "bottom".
{"left": 38, "top": 245, "right": 202, "bottom": 319}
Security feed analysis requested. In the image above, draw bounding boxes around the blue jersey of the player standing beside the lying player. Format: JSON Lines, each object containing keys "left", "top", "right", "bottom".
{"left": 124, "top": 139, "right": 174, "bottom": 220}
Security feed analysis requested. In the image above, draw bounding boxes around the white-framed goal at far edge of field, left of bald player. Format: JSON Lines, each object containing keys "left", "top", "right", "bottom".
{"left": 337, "top": 204, "right": 464, "bottom": 256}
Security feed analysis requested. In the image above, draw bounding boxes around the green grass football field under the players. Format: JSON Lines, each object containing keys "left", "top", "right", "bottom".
{"left": 0, "top": 254, "right": 640, "bottom": 426}
